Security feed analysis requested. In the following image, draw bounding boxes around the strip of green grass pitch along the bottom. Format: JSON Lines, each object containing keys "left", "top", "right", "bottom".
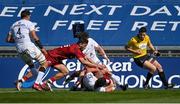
{"left": 0, "top": 88, "right": 180, "bottom": 103}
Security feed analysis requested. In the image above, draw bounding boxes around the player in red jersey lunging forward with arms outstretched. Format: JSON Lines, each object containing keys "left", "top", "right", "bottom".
{"left": 42, "top": 39, "right": 104, "bottom": 91}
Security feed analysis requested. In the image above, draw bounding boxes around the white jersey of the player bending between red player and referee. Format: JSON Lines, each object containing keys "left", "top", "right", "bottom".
{"left": 83, "top": 38, "right": 101, "bottom": 63}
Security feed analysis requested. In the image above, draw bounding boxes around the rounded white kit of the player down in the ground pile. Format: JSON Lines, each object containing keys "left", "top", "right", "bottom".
{"left": 83, "top": 72, "right": 97, "bottom": 90}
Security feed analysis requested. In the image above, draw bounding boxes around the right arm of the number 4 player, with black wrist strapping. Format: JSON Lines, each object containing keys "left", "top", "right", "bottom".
{"left": 30, "top": 30, "right": 47, "bottom": 54}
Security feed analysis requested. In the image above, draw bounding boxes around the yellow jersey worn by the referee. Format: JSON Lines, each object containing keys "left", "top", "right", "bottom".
{"left": 127, "top": 35, "right": 150, "bottom": 58}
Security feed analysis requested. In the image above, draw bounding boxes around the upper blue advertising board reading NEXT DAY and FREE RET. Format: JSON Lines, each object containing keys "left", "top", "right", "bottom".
{"left": 0, "top": 0, "right": 180, "bottom": 46}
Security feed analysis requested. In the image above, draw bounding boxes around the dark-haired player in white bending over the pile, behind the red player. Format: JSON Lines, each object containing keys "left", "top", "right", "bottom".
{"left": 65, "top": 32, "right": 128, "bottom": 90}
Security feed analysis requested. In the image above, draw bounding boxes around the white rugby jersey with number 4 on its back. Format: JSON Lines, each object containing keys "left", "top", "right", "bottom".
{"left": 10, "top": 19, "right": 35, "bottom": 52}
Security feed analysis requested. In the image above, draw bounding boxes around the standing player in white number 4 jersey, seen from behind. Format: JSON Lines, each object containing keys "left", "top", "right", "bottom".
{"left": 6, "top": 10, "right": 47, "bottom": 91}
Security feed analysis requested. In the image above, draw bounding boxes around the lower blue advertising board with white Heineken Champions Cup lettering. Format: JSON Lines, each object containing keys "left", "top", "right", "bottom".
{"left": 0, "top": 57, "right": 180, "bottom": 88}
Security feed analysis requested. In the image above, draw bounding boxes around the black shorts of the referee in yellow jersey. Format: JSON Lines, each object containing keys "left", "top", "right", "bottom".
{"left": 134, "top": 55, "right": 152, "bottom": 67}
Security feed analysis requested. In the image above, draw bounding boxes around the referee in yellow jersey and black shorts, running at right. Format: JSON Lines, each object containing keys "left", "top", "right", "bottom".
{"left": 125, "top": 27, "right": 174, "bottom": 89}
